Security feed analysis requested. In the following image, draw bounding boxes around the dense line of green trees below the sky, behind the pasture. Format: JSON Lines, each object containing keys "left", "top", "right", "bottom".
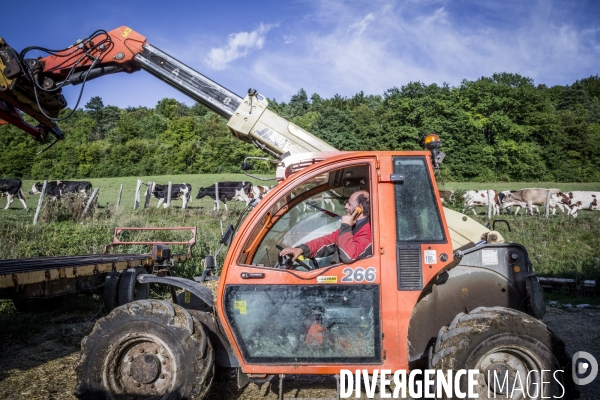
{"left": 0, "top": 73, "right": 600, "bottom": 182}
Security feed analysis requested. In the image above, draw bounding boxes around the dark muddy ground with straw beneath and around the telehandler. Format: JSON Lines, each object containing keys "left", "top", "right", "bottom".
{"left": 0, "top": 297, "right": 600, "bottom": 400}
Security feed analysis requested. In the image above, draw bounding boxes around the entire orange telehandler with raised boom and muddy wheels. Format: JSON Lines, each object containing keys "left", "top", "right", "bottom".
{"left": 0, "top": 27, "right": 577, "bottom": 399}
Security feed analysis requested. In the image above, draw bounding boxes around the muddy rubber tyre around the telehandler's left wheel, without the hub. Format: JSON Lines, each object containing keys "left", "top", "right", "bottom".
{"left": 75, "top": 300, "right": 215, "bottom": 400}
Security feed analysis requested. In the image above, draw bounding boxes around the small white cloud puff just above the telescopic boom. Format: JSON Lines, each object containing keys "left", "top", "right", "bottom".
{"left": 205, "top": 23, "right": 277, "bottom": 70}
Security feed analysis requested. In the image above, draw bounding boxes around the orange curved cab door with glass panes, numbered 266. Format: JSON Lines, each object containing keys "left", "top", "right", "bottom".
{"left": 218, "top": 157, "right": 383, "bottom": 374}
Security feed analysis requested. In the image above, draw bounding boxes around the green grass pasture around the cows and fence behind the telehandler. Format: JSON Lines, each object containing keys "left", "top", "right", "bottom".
{"left": 0, "top": 174, "right": 600, "bottom": 279}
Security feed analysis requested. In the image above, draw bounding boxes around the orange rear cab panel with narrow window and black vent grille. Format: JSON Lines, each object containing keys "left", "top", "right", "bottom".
{"left": 379, "top": 152, "right": 453, "bottom": 368}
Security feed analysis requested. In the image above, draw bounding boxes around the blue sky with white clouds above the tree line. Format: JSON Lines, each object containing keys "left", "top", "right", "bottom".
{"left": 0, "top": 0, "right": 600, "bottom": 107}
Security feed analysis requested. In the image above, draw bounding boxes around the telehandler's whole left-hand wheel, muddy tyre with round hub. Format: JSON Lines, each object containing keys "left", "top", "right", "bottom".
{"left": 75, "top": 300, "right": 215, "bottom": 399}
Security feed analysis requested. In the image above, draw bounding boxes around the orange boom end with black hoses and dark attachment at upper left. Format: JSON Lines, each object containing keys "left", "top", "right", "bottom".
{"left": 0, "top": 27, "right": 146, "bottom": 141}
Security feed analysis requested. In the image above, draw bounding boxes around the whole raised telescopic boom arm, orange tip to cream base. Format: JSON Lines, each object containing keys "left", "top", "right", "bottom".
{"left": 0, "top": 26, "right": 336, "bottom": 157}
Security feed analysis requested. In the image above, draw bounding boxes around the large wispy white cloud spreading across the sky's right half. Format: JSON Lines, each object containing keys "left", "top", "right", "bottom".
{"left": 241, "top": 0, "right": 599, "bottom": 100}
